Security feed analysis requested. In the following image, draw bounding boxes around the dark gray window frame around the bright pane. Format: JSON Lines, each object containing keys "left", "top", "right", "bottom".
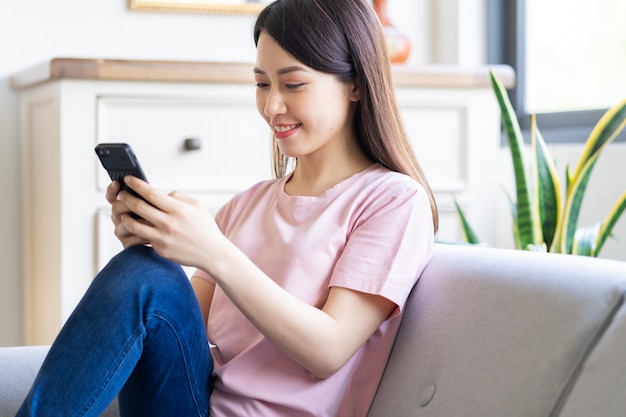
{"left": 487, "top": 0, "right": 626, "bottom": 143}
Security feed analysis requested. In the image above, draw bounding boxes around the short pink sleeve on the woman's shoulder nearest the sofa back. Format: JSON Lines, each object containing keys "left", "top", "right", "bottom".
{"left": 330, "top": 183, "right": 434, "bottom": 317}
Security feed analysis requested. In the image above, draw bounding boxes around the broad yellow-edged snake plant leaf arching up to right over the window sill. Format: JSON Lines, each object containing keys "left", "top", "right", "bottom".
{"left": 554, "top": 100, "right": 626, "bottom": 253}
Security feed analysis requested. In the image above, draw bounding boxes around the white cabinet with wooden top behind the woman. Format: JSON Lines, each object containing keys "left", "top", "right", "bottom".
{"left": 12, "top": 59, "right": 512, "bottom": 344}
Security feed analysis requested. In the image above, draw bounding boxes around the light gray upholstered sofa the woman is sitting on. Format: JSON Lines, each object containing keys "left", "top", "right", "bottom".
{"left": 0, "top": 244, "right": 626, "bottom": 417}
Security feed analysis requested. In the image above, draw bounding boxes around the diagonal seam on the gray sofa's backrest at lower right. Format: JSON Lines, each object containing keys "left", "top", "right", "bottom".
{"left": 548, "top": 289, "right": 626, "bottom": 417}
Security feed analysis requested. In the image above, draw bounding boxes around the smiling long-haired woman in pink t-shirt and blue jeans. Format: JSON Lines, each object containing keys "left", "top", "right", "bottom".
{"left": 18, "top": 0, "right": 437, "bottom": 417}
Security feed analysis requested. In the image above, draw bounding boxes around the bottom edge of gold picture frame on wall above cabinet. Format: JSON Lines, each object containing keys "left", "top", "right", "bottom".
{"left": 129, "top": 0, "right": 273, "bottom": 14}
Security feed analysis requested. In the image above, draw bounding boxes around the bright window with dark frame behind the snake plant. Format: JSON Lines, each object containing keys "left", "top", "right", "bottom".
{"left": 487, "top": 0, "right": 626, "bottom": 142}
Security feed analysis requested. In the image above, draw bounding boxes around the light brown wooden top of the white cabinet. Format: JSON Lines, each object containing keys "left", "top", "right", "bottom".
{"left": 11, "top": 58, "right": 515, "bottom": 90}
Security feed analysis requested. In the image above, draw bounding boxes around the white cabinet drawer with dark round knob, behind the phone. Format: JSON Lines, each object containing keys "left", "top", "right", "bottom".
{"left": 97, "top": 93, "right": 271, "bottom": 194}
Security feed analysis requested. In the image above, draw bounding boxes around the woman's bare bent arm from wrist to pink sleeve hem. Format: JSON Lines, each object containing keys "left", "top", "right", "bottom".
{"left": 210, "top": 242, "right": 396, "bottom": 378}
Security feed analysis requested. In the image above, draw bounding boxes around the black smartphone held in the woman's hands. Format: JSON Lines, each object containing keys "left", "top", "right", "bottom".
{"left": 96, "top": 143, "right": 148, "bottom": 217}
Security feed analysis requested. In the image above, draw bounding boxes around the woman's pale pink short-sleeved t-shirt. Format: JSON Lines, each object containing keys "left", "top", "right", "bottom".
{"left": 196, "top": 164, "right": 434, "bottom": 417}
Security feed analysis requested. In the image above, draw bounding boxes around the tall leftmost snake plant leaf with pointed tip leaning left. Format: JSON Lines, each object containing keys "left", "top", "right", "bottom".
{"left": 489, "top": 71, "right": 537, "bottom": 248}
